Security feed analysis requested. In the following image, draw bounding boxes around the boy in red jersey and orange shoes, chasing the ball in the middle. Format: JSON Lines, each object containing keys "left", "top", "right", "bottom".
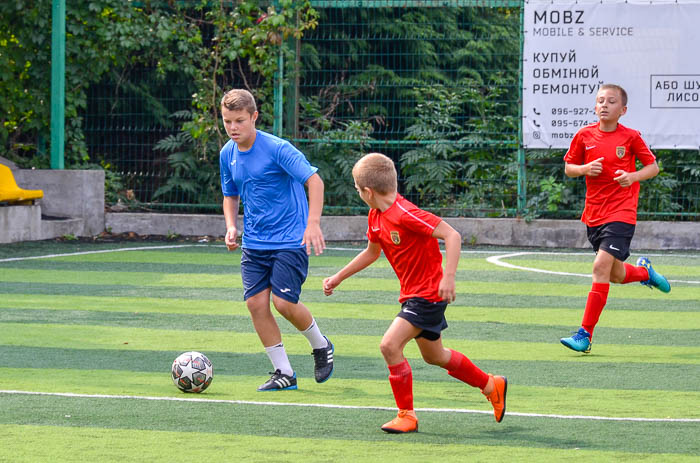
{"left": 323, "top": 153, "right": 508, "bottom": 433}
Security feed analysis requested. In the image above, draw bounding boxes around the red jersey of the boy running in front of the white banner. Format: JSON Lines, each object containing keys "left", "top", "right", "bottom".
{"left": 564, "top": 122, "right": 656, "bottom": 227}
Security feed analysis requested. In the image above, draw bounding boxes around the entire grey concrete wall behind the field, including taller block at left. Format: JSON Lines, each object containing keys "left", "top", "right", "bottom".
{"left": 0, "top": 163, "right": 700, "bottom": 250}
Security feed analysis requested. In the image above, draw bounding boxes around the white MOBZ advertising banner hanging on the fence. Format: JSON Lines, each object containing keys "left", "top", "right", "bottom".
{"left": 523, "top": 0, "right": 700, "bottom": 150}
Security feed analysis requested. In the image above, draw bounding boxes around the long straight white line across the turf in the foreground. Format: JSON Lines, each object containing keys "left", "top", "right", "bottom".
{"left": 0, "top": 390, "right": 700, "bottom": 423}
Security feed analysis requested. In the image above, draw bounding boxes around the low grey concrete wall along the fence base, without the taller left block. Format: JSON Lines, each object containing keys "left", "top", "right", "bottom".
{"left": 105, "top": 213, "right": 700, "bottom": 250}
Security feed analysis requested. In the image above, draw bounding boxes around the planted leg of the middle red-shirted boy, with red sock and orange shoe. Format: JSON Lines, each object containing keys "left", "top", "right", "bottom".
{"left": 379, "top": 317, "right": 422, "bottom": 433}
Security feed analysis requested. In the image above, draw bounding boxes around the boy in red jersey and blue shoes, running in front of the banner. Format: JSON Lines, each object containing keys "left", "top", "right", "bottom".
{"left": 561, "top": 84, "right": 671, "bottom": 353}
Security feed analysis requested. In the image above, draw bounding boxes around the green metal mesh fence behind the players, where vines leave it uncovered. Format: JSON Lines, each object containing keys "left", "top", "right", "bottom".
{"left": 85, "top": 0, "right": 700, "bottom": 220}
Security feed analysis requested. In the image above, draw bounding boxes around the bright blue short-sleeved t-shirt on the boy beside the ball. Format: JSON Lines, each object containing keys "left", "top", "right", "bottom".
{"left": 219, "top": 130, "right": 318, "bottom": 249}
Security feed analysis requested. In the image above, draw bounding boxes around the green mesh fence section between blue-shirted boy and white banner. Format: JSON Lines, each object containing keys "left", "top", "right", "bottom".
{"left": 295, "top": 1, "right": 520, "bottom": 216}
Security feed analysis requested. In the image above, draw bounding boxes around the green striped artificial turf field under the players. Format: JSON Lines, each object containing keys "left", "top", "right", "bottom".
{"left": 0, "top": 242, "right": 700, "bottom": 462}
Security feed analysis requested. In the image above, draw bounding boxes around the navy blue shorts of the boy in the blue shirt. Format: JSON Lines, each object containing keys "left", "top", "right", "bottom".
{"left": 241, "top": 248, "right": 309, "bottom": 304}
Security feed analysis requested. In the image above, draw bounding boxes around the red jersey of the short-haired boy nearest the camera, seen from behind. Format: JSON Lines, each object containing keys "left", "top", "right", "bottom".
{"left": 367, "top": 194, "right": 442, "bottom": 302}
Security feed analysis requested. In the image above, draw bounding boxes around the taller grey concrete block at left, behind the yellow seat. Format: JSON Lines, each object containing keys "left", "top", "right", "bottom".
{"left": 13, "top": 169, "right": 105, "bottom": 236}
